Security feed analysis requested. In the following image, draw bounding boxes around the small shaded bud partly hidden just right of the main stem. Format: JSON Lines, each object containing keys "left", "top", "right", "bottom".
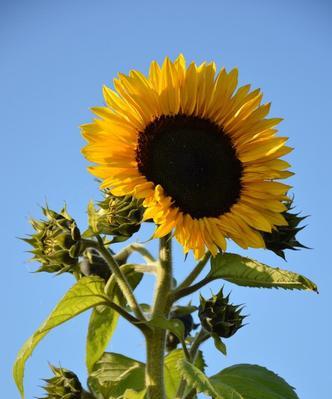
{"left": 166, "top": 306, "right": 199, "bottom": 352}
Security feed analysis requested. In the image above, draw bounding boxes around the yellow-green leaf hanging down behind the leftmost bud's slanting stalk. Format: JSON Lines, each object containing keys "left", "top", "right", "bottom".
{"left": 86, "top": 268, "right": 143, "bottom": 372}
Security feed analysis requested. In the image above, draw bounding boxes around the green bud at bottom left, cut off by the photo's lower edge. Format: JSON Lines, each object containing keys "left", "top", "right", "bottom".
{"left": 39, "top": 365, "right": 83, "bottom": 399}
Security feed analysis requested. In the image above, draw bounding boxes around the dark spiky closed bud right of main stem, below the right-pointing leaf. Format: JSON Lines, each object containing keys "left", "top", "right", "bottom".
{"left": 198, "top": 289, "right": 246, "bottom": 338}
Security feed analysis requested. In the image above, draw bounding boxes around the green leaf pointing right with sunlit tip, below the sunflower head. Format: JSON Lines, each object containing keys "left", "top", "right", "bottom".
{"left": 208, "top": 253, "right": 317, "bottom": 292}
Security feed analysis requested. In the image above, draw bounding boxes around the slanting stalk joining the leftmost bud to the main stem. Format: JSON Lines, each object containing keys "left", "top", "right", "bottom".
{"left": 84, "top": 236, "right": 145, "bottom": 320}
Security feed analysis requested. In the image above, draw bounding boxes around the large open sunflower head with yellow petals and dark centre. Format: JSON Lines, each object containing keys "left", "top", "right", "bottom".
{"left": 82, "top": 55, "right": 292, "bottom": 258}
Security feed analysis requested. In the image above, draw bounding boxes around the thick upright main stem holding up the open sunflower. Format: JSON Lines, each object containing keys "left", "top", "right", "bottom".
{"left": 145, "top": 234, "right": 173, "bottom": 399}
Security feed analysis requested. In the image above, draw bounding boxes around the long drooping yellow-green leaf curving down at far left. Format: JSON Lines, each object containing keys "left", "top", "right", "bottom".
{"left": 13, "top": 276, "right": 108, "bottom": 398}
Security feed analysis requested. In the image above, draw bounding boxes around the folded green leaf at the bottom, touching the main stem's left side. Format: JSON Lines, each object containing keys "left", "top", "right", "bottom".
{"left": 88, "top": 353, "right": 145, "bottom": 399}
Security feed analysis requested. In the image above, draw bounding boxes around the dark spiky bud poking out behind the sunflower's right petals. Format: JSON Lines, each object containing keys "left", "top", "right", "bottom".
{"left": 263, "top": 200, "right": 307, "bottom": 259}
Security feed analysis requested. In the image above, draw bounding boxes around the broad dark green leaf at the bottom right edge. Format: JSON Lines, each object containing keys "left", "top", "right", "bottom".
{"left": 210, "top": 364, "right": 299, "bottom": 399}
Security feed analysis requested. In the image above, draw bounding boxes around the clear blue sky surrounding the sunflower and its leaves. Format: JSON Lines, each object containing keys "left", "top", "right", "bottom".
{"left": 0, "top": 0, "right": 332, "bottom": 399}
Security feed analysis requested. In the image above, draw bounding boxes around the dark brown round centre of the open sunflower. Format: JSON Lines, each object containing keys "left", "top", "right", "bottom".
{"left": 136, "top": 114, "right": 243, "bottom": 219}
